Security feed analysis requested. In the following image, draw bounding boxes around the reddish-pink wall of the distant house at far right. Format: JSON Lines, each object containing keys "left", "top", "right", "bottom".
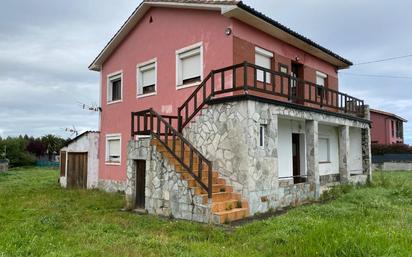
{"left": 371, "top": 111, "right": 403, "bottom": 144}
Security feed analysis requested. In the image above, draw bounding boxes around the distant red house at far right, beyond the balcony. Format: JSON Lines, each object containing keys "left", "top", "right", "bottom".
{"left": 370, "top": 109, "right": 408, "bottom": 145}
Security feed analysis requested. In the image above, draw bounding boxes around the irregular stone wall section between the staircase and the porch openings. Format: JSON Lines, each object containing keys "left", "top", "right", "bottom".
{"left": 184, "top": 101, "right": 278, "bottom": 214}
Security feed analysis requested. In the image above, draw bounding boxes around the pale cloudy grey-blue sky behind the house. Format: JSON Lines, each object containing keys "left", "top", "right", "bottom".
{"left": 0, "top": 0, "right": 412, "bottom": 144}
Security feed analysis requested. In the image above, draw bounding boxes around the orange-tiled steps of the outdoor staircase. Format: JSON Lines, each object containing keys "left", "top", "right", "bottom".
{"left": 151, "top": 138, "right": 249, "bottom": 224}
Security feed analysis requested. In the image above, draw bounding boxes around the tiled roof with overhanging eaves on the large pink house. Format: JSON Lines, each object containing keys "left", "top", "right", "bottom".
{"left": 89, "top": 0, "right": 352, "bottom": 71}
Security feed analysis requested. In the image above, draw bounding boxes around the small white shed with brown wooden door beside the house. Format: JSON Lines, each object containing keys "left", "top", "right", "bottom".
{"left": 60, "top": 131, "right": 99, "bottom": 189}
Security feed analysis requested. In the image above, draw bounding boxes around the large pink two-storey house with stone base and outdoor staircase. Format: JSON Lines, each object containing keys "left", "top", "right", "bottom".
{"left": 89, "top": 0, "right": 371, "bottom": 223}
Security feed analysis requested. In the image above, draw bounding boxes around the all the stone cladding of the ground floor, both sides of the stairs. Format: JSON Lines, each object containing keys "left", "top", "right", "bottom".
{"left": 124, "top": 100, "right": 370, "bottom": 222}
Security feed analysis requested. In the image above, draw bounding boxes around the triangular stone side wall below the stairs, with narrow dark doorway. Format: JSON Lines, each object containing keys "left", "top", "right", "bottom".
{"left": 126, "top": 139, "right": 212, "bottom": 223}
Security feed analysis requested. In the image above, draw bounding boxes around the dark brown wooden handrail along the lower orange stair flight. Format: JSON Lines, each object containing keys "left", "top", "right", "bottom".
{"left": 131, "top": 109, "right": 213, "bottom": 199}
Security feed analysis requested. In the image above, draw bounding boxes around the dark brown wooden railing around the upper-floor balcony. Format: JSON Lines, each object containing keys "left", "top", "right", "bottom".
{"left": 178, "top": 62, "right": 364, "bottom": 131}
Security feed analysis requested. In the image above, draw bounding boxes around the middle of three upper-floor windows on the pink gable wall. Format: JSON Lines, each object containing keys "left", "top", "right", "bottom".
{"left": 137, "top": 59, "right": 157, "bottom": 96}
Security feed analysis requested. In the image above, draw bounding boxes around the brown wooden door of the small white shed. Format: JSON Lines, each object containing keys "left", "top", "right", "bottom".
{"left": 67, "top": 153, "right": 87, "bottom": 188}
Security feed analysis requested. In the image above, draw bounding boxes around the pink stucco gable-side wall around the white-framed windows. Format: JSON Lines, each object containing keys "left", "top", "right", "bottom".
{"left": 99, "top": 8, "right": 233, "bottom": 180}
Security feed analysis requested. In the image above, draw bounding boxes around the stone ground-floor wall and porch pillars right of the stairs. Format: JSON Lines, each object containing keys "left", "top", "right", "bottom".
{"left": 183, "top": 100, "right": 369, "bottom": 215}
